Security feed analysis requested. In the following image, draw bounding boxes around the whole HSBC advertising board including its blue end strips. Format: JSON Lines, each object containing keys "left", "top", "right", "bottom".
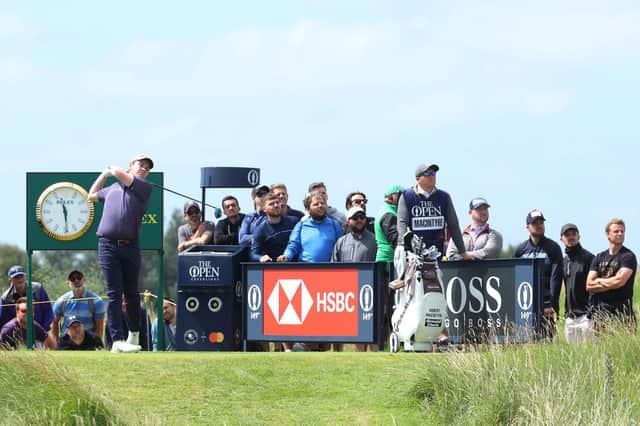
{"left": 246, "top": 263, "right": 377, "bottom": 342}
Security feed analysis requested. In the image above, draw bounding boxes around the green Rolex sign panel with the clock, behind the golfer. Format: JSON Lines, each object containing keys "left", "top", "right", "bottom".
{"left": 26, "top": 172, "right": 163, "bottom": 251}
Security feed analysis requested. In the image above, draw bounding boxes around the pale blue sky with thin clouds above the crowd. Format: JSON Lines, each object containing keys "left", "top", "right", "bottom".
{"left": 0, "top": 0, "right": 640, "bottom": 252}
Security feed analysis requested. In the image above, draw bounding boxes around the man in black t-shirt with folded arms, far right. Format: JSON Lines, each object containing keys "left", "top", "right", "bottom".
{"left": 587, "top": 218, "right": 638, "bottom": 328}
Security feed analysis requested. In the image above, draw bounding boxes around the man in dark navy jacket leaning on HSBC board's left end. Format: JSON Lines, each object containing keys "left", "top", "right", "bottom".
{"left": 250, "top": 192, "right": 297, "bottom": 262}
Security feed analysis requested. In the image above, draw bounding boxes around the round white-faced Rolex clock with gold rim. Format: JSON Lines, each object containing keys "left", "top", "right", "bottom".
{"left": 36, "top": 182, "right": 94, "bottom": 241}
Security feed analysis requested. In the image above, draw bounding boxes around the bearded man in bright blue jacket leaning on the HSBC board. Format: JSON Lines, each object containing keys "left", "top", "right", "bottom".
{"left": 277, "top": 191, "right": 342, "bottom": 262}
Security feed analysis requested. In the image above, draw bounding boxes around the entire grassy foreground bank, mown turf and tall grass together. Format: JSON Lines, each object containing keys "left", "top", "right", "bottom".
{"left": 5, "top": 332, "right": 640, "bottom": 425}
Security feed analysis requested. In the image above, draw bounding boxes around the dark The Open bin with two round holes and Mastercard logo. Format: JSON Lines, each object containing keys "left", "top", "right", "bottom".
{"left": 176, "top": 245, "right": 248, "bottom": 351}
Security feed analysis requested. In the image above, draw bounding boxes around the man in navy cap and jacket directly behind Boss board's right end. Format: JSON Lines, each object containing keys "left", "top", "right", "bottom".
{"left": 513, "top": 210, "right": 562, "bottom": 339}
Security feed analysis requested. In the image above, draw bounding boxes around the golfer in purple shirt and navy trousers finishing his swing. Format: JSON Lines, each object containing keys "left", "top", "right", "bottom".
{"left": 88, "top": 154, "right": 153, "bottom": 352}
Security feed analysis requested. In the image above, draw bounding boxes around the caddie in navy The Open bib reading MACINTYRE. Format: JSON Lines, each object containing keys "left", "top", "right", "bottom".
{"left": 397, "top": 164, "right": 471, "bottom": 259}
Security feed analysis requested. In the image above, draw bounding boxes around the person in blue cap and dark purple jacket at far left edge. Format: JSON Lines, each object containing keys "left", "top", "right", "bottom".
{"left": 0, "top": 265, "right": 53, "bottom": 332}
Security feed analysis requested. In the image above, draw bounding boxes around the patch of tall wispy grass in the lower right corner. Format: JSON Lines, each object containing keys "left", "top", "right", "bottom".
{"left": 412, "top": 327, "right": 640, "bottom": 425}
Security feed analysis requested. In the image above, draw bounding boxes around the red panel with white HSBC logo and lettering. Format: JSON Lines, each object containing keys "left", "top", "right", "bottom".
{"left": 263, "top": 269, "right": 358, "bottom": 336}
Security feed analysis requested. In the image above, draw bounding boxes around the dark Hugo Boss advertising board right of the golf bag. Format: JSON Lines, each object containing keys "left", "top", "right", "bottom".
{"left": 441, "top": 259, "right": 542, "bottom": 343}
